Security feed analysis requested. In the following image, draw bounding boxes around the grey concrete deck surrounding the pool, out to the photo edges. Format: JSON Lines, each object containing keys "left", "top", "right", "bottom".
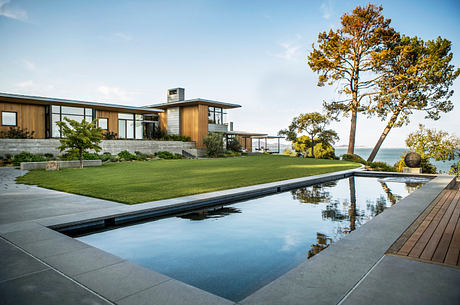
{"left": 0, "top": 168, "right": 460, "bottom": 304}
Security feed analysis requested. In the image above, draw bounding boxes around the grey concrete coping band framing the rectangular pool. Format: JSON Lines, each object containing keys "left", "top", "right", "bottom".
{"left": 0, "top": 168, "right": 455, "bottom": 304}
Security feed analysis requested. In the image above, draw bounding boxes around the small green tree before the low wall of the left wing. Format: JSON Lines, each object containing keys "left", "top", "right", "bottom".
{"left": 57, "top": 118, "right": 103, "bottom": 168}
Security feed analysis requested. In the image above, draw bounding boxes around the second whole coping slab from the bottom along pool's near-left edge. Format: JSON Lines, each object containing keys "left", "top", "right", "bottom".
{"left": 43, "top": 247, "right": 123, "bottom": 276}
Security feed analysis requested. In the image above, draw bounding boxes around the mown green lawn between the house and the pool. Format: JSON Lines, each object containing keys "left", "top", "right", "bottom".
{"left": 17, "top": 155, "right": 360, "bottom": 204}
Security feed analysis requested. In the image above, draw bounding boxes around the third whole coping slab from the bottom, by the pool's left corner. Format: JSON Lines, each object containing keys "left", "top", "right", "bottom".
{"left": 16, "top": 235, "right": 89, "bottom": 259}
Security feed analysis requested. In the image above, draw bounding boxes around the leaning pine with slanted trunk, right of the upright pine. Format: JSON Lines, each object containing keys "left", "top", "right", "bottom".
{"left": 367, "top": 36, "right": 460, "bottom": 162}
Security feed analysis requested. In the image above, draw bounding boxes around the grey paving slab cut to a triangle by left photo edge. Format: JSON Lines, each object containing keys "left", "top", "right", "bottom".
{"left": 0, "top": 238, "right": 49, "bottom": 282}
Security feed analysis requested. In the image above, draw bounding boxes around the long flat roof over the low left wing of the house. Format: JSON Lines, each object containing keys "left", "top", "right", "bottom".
{"left": 0, "top": 92, "right": 164, "bottom": 113}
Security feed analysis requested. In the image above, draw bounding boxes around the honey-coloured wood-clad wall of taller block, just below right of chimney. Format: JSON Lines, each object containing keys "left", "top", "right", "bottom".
{"left": 180, "top": 105, "right": 208, "bottom": 148}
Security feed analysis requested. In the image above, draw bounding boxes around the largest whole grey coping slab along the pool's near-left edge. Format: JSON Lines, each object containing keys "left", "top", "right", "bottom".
{"left": 75, "top": 261, "right": 171, "bottom": 302}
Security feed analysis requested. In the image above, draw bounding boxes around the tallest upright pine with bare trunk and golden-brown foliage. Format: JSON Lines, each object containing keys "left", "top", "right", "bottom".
{"left": 308, "top": 4, "right": 398, "bottom": 154}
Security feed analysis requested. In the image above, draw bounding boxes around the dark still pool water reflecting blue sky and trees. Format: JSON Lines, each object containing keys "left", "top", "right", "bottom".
{"left": 78, "top": 177, "right": 426, "bottom": 301}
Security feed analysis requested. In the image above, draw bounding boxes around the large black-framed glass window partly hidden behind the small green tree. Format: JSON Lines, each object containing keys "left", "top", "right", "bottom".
{"left": 51, "top": 105, "right": 94, "bottom": 138}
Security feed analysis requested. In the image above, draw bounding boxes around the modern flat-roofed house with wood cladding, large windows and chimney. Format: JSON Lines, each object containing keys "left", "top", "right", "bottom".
{"left": 0, "top": 88, "right": 280, "bottom": 152}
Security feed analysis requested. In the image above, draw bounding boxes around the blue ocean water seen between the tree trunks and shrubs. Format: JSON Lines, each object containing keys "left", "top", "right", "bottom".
{"left": 335, "top": 147, "right": 460, "bottom": 173}
